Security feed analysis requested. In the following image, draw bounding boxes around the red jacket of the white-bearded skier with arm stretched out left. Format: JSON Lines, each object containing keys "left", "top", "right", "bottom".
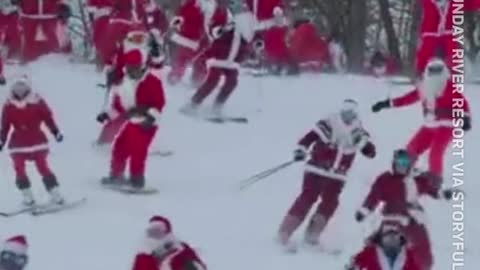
{"left": 390, "top": 81, "right": 470, "bottom": 127}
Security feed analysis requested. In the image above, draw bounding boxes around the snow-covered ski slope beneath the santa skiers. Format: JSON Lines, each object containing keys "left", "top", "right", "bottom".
{"left": 0, "top": 56, "right": 480, "bottom": 270}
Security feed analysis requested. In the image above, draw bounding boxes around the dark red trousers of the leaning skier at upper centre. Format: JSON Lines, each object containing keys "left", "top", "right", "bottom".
{"left": 192, "top": 67, "right": 238, "bottom": 104}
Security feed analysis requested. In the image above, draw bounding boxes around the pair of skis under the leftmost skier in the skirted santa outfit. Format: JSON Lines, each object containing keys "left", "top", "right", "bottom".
{"left": 0, "top": 198, "right": 87, "bottom": 218}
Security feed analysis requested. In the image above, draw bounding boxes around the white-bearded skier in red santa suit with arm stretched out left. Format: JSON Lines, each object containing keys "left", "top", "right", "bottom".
{"left": 372, "top": 57, "right": 471, "bottom": 184}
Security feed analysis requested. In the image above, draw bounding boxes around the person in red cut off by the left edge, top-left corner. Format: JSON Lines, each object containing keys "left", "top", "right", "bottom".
{"left": 0, "top": 0, "right": 22, "bottom": 58}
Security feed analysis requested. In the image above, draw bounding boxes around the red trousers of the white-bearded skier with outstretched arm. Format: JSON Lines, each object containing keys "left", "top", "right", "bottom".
{"left": 407, "top": 126, "right": 453, "bottom": 177}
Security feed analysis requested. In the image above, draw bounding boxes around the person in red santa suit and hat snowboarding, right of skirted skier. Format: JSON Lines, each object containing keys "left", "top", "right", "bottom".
{"left": 97, "top": 47, "right": 165, "bottom": 189}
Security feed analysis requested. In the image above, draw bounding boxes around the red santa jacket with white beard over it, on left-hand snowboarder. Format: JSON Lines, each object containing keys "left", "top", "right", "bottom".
{"left": 107, "top": 71, "right": 165, "bottom": 123}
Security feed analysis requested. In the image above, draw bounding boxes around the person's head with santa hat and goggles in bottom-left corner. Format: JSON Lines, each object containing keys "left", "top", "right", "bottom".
{"left": 0, "top": 235, "right": 29, "bottom": 270}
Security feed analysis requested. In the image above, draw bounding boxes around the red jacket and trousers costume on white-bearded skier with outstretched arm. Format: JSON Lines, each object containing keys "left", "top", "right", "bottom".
{"left": 390, "top": 60, "right": 470, "bottom": 177}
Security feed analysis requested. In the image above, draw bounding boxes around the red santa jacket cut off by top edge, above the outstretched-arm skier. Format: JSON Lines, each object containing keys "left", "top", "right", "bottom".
{"left": 420, "top": 0, "right": 454, "bottom": 37}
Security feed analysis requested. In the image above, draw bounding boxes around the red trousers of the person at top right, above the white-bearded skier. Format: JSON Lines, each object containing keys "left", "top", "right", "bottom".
{"left": 415, "top": 35, "right": 458, "bottom": 74}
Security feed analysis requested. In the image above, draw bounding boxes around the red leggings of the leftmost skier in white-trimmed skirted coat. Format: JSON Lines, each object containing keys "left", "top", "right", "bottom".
{"left": 11, "top": 150, "right": 53, "bottom": 181}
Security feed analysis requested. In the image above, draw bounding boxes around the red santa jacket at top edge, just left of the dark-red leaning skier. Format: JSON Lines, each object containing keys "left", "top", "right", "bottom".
{"left": 171, "top": 0, "right": 205, "bottom": 51}
